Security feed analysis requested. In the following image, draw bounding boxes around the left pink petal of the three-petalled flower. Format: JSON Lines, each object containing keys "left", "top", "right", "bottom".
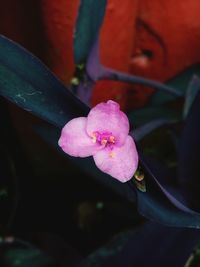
{"left": 58, "top": 117, "right": 101, "bottom": 157}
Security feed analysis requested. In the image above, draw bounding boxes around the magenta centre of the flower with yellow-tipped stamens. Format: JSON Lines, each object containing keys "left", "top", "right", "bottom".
{"left": 91, "top": 131, "right": 116, "bottom": 148}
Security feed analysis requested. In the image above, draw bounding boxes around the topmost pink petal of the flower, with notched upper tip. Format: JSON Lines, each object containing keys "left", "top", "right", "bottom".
{"left": 86, "top": 100, "right": 129, "bottom": 146}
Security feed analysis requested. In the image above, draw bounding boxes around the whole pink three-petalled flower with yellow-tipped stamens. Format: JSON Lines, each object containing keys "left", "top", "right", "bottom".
{"left": 58, "top": 100, "right": 138, "bottom": 182}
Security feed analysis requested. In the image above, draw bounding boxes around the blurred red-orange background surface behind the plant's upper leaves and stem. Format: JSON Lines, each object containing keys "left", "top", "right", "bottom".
{"left": 0, "top": 0, "right": 200, "bottom": 109}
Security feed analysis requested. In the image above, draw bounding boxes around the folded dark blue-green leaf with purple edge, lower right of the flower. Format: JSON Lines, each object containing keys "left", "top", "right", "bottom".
{"left": 137, "top": 160, "right": 200, "bottom": 229}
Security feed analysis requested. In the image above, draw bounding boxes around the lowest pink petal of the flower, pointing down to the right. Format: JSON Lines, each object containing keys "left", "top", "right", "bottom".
{"left": 93, "top": 136, "right": 138, "bottom": 183}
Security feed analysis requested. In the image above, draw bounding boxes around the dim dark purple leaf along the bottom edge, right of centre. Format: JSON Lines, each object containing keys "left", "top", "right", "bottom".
{"left": 80, "top": 223, "right": 200, "bottom": 267}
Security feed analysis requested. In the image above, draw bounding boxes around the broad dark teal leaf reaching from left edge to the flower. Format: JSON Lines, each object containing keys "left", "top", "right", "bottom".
{"left": 0, "top": 36, "right": 89, "bottom": 127}
